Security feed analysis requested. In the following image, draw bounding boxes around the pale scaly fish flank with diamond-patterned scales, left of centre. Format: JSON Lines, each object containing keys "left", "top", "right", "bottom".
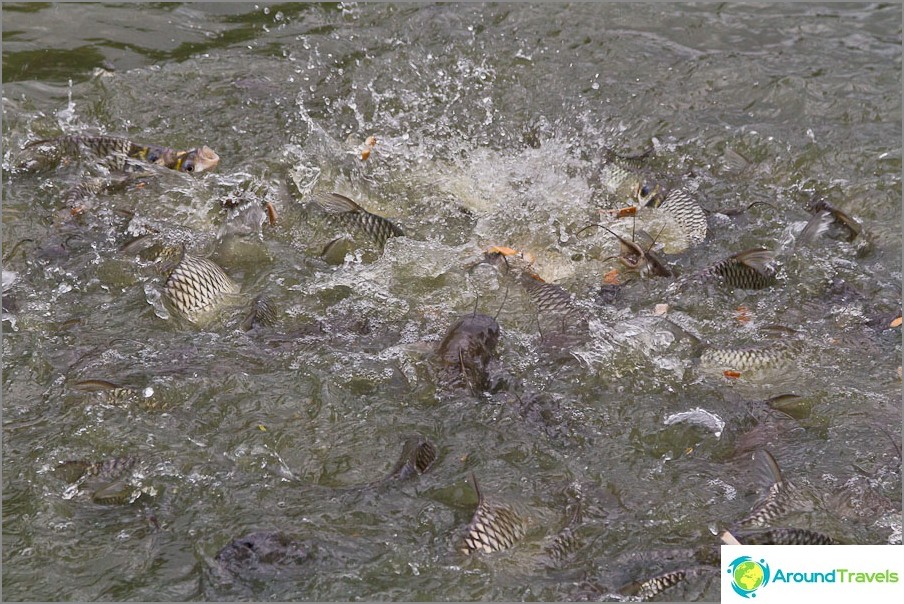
{"left": 163, "top": 249, "right": 239, "bottom": 323}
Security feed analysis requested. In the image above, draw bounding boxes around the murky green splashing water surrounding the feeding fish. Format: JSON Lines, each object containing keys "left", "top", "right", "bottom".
{"left": 2, "top": 3, "right": 902, "bottom": 600}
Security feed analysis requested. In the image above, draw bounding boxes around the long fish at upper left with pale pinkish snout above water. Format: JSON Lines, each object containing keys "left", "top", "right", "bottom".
{"left": 19, "top": 135, "right": 220, "bottom": 172}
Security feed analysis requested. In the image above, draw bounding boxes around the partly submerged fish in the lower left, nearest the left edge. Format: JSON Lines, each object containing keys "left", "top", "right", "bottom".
{"left": 54, "top": 455, "right": 140, "bottom": 505}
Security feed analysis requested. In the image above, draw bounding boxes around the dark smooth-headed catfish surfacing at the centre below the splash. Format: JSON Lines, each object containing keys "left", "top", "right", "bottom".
{"left": 435, "top": 313, "right": 500, "bottom": 393}
